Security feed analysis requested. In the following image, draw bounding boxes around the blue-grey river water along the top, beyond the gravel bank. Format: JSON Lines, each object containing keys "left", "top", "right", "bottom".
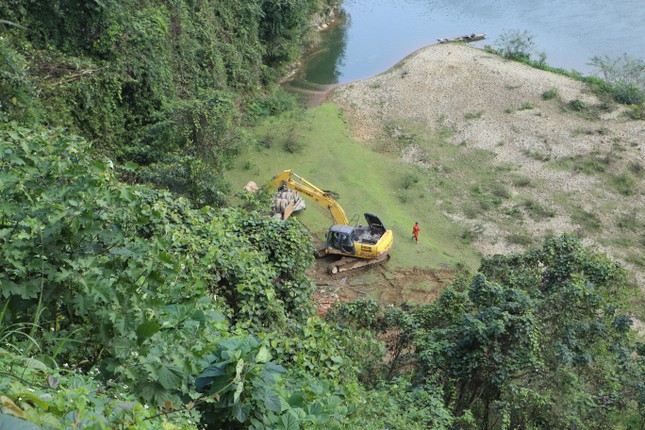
{"left": 296, "top": 0, "right": 645, "bottom": 85}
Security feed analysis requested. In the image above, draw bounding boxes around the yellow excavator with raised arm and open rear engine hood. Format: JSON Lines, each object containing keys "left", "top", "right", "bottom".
{"left": 269, "top": 170, "right": 394, "bottom": 274}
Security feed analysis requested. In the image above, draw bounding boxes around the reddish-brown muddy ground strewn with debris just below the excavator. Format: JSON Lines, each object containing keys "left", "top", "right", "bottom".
{"left": 311, "top": 256, "right": 455, "bottom": 314}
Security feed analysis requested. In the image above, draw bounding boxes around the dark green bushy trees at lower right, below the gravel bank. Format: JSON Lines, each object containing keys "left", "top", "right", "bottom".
{"left": 334, "top": 236, "right": 645, "bottom": 429}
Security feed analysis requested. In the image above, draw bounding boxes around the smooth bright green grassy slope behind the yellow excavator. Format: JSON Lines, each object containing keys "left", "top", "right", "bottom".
{"left": 227, "top": 104, "right": 479, "bottom": 269}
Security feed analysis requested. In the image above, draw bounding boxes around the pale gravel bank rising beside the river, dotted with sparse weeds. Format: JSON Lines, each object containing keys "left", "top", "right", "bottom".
{"left": 329, "top": 44, "right": 645, "bottom": 298}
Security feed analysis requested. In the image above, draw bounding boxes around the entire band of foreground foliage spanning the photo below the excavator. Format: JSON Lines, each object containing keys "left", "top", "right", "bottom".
{"left": 0, "top": 123, "right": 645, "bottom": 429}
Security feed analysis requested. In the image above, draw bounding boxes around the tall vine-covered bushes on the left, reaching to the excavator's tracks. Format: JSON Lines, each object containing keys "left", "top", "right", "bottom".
{"left": 0, "top": 123, "right": 378, "bottom": 427}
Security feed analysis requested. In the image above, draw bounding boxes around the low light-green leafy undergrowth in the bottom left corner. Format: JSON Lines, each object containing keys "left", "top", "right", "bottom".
{"left": 0, "top": 350, "right": 197, "bottom": 430}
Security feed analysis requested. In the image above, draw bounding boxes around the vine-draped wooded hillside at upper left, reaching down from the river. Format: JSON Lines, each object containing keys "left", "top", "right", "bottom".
{"left": 0, "top": 0, "right": 333, "bottom": 206}
